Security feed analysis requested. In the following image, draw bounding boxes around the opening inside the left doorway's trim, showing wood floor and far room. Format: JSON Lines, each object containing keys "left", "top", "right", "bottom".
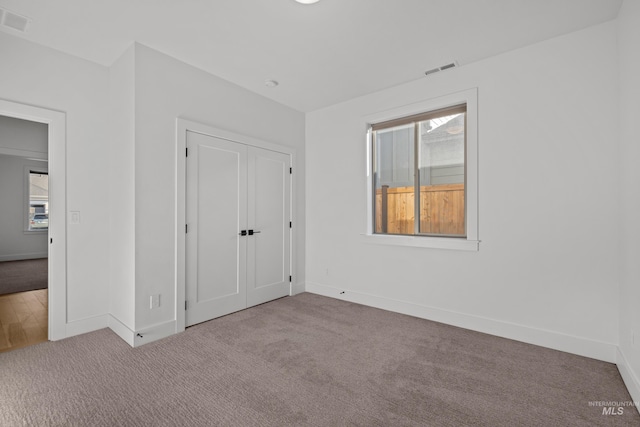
{"left": 0, "top": 116, "right": 49, "bottom": 352}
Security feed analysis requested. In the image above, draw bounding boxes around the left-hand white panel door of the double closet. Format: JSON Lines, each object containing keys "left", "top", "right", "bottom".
{"left": 185, "top": 132, "right": 247, "bottom": 326}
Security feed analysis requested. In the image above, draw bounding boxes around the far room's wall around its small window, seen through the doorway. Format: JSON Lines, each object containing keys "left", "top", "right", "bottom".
{"left": 0, "top": 154, "right": 47, "bottom": 261}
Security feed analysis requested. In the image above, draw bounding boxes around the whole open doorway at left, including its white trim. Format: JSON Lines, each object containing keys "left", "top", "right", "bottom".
{"left": 0, "top": 99, "right": 66, "bottom": 344}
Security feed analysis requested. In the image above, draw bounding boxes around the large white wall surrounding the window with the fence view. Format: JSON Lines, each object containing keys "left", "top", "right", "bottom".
{"left": 306, "top": 23, "right": 618, "bottom": 361}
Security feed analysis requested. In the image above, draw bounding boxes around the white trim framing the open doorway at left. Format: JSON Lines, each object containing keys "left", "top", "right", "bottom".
{"left": 0, "top": 99, "right": 67, "bottom": 341}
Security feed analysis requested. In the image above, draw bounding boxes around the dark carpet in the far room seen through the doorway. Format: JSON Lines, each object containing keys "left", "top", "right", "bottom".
{"left": 0, "top": 258, "right": 49, "bottom": 295}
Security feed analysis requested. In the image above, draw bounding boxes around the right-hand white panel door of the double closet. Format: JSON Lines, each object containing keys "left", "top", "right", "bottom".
{"left": 247, "top": 147, "right": 291, "bottom": 307}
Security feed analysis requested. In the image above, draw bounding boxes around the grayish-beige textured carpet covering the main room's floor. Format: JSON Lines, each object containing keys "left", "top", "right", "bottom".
{"left": 0, "top": 293, "right": 640, "bottom": 426}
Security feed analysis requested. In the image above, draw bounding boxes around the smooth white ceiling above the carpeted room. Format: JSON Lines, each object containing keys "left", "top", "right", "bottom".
{"left": 0, "top": 0, "right": 622, "bottom": 112}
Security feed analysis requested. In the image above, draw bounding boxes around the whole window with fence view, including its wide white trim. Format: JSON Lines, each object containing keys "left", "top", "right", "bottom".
{"left": 366, "top": 89, "right": 478, "bottom": 250}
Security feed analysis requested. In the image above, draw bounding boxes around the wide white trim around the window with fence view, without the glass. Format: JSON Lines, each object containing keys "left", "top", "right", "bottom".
{"left": 363, "top": 88, "right": 480, "bottom": 251}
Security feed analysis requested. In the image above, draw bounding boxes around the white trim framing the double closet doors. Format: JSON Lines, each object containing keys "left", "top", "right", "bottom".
{"left": 175, "top": 117, "right": 298, "bottom": 333}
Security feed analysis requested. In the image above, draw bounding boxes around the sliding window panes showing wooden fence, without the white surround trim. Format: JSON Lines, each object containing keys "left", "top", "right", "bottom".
{"left": 372, "top": 105, "right": 467, "bottom": 237}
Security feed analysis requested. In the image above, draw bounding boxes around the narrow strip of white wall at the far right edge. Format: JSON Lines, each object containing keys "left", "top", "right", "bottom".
{"left": 618, "top": 0, "right": 640, "bottom": 402}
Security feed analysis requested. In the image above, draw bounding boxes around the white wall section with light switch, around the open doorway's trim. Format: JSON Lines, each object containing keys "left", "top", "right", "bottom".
{"left": 0, "top": 33, "right": 110, "bottom": 334}
